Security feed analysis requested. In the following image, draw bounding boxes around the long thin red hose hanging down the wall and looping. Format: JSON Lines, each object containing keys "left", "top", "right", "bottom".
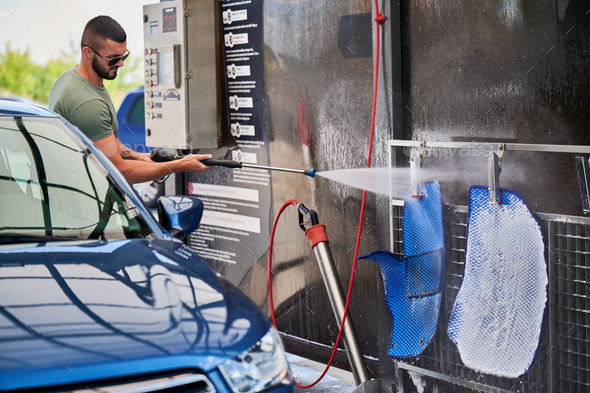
{"left": 268, "top": 0, "right": 385, "bottom": 389}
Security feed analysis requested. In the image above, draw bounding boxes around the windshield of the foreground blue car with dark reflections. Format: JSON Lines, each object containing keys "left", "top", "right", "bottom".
{"left": 0, "top": 117, "right": 153, "bottom": 243}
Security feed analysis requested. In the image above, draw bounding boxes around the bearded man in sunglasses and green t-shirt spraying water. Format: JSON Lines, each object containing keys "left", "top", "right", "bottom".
{"left": 49, "top": 15, "right": 211, "bottom": 183}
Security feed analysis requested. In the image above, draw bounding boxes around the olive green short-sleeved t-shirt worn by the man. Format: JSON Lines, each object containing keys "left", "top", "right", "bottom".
{"left": 49, "top": 67, "right": 119, "bottom": 141}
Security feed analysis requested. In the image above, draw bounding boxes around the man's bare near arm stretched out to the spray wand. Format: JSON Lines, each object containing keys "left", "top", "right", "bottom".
{"left": 94, "top": 134, "right": 211, "bottom": 183}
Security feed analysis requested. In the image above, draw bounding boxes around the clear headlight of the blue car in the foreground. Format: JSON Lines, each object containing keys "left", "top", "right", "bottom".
{"left": 219, "top": 328, "right": 289, "bottom": 393}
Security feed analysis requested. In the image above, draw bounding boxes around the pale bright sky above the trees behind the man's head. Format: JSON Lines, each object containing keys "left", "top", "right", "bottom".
{"left": 0, "top": 0, "right": 159, "bottom": 64}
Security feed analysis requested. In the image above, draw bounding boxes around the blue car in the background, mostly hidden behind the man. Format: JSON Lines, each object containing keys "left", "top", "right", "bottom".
{"left": 117, "top": 87, "right": 164, "bottom": 208}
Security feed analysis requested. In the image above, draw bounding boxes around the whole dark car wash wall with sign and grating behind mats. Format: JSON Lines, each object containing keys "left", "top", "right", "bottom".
{"left": 177, "top": 0, "right": 590, "bottom": 392}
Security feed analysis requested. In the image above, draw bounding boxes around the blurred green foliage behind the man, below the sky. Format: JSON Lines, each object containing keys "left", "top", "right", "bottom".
{"left": 0, "top": 42, "right": 142, "bottom": 108}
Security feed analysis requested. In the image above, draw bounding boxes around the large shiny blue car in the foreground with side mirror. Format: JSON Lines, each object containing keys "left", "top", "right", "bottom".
{"left": 0, "top": 100, "right": 294, "bottom": 393}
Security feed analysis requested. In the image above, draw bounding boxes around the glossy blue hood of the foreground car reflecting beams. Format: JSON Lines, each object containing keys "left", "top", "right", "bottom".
{"left": 0, "top": 239, "right": 270, "bottom": 390}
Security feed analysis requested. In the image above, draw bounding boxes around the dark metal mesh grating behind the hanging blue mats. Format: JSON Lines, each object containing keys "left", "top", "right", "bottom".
{"left": 391, "top": 206, "right": 590, "bottom": 393}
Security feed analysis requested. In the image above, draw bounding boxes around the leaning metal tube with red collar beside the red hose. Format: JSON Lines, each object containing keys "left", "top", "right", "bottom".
{"left": 305, "top": 225, "right": 371, "bottom": 386}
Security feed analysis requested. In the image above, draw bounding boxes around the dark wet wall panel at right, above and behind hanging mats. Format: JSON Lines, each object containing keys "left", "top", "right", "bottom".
{"left": 402, "top": 0, "right": 590, "bottom": 215}
